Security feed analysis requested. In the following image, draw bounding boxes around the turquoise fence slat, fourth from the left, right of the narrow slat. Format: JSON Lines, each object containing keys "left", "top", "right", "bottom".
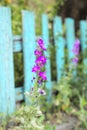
{"left": 53, "top": 16, "right": 65, "bottom": 81}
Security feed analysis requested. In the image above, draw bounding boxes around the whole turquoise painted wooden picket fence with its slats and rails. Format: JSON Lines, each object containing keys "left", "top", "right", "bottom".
{"left": 0, "top": 7, "right": 87, "bottom": 114}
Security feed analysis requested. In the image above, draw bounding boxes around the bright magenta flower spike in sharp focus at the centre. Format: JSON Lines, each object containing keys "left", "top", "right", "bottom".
{"left": 31, "top": 38, "right": 47, "bottom": 85}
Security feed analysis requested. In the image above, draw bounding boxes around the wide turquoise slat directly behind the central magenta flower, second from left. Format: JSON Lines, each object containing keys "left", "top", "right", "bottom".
{"left": 22, "top": 11, "right": 36, "bottom": 104}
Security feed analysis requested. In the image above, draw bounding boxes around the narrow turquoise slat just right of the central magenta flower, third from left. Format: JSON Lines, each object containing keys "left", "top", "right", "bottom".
{"left": 42, "top": 14, "right": 52, "bottom": 100}
